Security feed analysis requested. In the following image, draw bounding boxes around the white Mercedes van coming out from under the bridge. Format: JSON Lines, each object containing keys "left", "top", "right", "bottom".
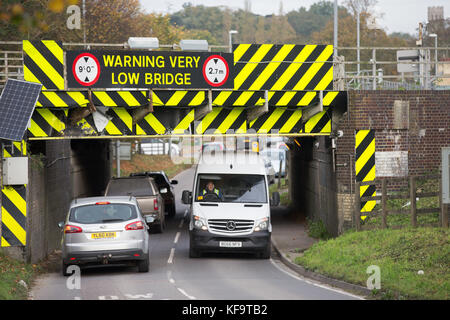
{"left": 182, "top": 151, "right": 280, "bottom": 259}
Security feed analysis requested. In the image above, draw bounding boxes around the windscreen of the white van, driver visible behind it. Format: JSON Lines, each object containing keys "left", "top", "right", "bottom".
{"left": 195, "top": 174, "right": 267, "bottom": 203}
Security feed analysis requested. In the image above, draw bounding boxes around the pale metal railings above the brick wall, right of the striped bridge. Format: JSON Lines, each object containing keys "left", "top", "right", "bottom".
{"left": 334, "top": 47, "right": 450, "bottom": 90}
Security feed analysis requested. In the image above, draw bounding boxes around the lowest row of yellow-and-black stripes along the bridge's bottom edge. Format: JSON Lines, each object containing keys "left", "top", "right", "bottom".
{"left": 27, "top": 107, "right": 332, "bottom": 138}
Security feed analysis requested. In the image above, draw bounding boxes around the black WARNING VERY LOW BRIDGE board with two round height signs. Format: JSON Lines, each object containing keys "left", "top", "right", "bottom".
{"left": 66, "top": 50, "right": 234, "bottom": 89}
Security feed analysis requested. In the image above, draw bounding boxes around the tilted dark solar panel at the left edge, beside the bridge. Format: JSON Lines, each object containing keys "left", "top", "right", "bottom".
{"left": 0, "top": 79, "right": 42, "bottom": 141}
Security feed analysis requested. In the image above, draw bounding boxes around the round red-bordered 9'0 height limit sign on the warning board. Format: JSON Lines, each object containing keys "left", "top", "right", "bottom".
{"left": 72, "top": 52, "right": 100, "bottom": 87}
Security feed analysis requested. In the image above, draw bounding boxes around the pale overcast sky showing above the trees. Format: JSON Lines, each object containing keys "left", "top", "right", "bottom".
{"left": 140, "top": 0, "right": 450, "bottom": 35}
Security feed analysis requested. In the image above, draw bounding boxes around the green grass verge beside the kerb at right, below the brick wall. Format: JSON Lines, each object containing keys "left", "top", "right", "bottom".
{"left": 295, "top": 228, "right": 450, "bottom": 300}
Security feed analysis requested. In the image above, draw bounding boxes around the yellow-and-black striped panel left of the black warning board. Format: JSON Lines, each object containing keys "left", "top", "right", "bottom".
{"left": 22, "top": 40, "right": 64, "bottom": 90}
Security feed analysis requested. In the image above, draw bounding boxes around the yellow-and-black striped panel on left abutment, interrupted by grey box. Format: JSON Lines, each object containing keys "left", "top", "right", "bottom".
{"left": 0, "top": 140, "right": 27, "bottom": 247}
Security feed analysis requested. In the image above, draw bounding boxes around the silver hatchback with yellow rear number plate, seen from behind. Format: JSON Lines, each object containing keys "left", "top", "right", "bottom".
{"left": 59, "top": 196, "right": 153, "bottom": 276}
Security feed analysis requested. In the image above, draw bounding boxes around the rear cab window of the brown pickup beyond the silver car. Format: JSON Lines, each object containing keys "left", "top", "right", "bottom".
{"left": 106, "top": 178, "right": 154, "bottom": 197}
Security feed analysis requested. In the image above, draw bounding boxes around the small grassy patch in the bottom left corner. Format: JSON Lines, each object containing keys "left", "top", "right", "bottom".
{"left": 0, "top": 252, "right": 40, "bottom": 300}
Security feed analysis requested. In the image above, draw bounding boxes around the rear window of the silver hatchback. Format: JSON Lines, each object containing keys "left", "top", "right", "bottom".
{"left": 69, "top": 203, "right": 137, "bottom": 224}
